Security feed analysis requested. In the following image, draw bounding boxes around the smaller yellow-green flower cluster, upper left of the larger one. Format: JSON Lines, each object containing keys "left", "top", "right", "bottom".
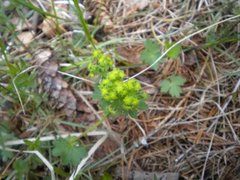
{"left": 88, "top": 50, "right": 113, "bottom": 77}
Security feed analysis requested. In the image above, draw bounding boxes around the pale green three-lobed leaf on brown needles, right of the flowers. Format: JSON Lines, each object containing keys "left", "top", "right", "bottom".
{"left": 160, "top": 75, "right": 186, "bottom": 97}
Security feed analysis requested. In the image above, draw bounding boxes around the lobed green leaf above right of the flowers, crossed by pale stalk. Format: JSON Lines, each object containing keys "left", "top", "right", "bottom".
{"left": 140, "top": 40, "right": 161, "bottom": 70}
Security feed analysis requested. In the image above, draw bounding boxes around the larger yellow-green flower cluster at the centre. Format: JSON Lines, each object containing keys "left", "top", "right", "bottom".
{"left": 99, "top": 69, "right": 145, "bottom": 114}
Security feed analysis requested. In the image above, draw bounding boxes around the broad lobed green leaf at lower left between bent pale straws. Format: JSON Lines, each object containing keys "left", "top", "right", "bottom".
{"left": 52, "top": 137, "right": 87, "bottom": 165}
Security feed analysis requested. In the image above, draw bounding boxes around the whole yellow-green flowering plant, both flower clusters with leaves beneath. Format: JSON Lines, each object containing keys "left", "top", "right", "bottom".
{"left": 88, "top": 50, "right": 147, "bottom": 117}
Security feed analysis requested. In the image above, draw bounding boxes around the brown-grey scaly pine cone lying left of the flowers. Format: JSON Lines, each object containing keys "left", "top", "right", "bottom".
{"left": 33, "top": 48, "right": 77, "bottom": 117}
